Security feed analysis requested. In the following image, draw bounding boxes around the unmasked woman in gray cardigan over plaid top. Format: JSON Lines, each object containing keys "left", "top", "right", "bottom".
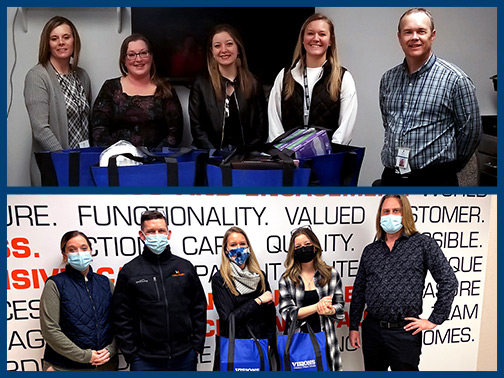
{"left": 24, "top": 16, "right": 91, "bottom": 186}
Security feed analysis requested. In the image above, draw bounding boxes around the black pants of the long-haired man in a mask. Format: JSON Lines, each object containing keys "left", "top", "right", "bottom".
{"left": 362, "top": 315, "right": 422, "bottom": 371}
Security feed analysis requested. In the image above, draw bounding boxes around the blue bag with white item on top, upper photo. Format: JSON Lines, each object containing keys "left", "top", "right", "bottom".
{"left": 91, "top": 149, "right": 205, "bottom": 187}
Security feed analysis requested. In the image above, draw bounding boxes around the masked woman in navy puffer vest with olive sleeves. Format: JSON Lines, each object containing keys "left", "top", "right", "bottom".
{"left": 40, "top": 231, "right": 118, "bottom": 370}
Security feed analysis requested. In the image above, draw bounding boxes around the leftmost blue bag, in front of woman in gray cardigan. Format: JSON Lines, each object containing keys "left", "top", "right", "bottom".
{"left": 35, "top": 147, "right": 103, "bottom": 186}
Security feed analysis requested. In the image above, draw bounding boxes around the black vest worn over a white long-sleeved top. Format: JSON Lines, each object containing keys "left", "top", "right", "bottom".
{"left": 281, "top": 62, "right": 346, "bottom": 140}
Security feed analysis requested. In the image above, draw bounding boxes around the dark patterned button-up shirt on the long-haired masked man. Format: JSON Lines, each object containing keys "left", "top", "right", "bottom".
{"left": 350, "top": 233, "right": 458, "bottom": 330}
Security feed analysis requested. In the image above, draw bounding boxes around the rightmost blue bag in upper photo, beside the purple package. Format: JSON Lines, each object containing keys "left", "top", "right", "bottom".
{"left": 300, "top": 143, "right": 366, "bottom": 186}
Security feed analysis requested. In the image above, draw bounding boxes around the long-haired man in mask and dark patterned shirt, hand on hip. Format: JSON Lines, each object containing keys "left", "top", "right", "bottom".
{"left": 350, "top": 195, "right": 458, "bottom": 370}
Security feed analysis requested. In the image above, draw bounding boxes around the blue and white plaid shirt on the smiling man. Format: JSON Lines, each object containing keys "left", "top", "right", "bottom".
{"left": 380, "top": 54, "right": 481, "bottom": 170}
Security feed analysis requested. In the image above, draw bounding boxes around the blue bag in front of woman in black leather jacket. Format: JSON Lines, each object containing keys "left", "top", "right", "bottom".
{"left": 207, "top": 145, "right": 310, "bottom": 187}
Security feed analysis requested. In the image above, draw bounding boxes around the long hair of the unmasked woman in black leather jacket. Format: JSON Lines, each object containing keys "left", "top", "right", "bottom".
{"left": 207, "top": 24, "right": 258, "bottom": 99}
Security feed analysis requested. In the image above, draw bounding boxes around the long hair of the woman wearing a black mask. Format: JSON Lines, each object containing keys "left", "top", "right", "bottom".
{"left": 282, "top": 227, "right": 332, "bottom": 286}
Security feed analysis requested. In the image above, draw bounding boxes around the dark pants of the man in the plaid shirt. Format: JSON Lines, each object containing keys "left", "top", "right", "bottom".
{"left": 381, "top": 163, "right": 458, "bottom": 186}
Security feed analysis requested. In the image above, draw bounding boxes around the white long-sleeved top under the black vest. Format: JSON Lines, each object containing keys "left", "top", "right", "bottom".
{"left": 268, "top": 62, "right": 357, "bottom": 144}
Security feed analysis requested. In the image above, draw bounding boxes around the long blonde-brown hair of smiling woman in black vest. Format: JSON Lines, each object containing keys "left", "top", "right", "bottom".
{"left": 284, "top": 13, "right": 342, "bottom": 101}
